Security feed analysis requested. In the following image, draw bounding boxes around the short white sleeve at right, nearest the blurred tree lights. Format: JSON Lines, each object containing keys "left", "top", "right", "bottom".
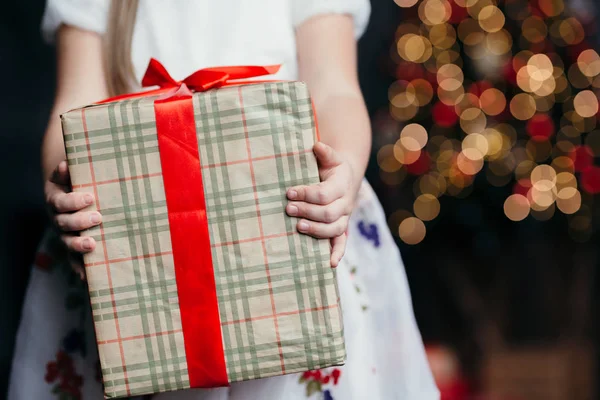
{"left": 290, "top": 0, "right": 371, "bottom": 38}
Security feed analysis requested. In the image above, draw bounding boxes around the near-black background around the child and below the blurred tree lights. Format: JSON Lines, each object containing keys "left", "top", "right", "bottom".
{"left": 0, "top": 0, "right": 600, "bottom": 393}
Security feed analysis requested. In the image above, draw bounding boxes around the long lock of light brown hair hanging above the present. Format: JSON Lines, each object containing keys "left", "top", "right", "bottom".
{"left": 104, "top": 0, "right": 139, "bottom": 96}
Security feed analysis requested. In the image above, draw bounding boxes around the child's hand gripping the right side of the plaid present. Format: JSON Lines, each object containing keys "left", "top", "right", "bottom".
{"left": 286, "top": 142, "right": 356, "bottom": 268}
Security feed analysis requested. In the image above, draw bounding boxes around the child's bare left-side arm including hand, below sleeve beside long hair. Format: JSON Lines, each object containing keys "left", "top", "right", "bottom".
{"left": 42, "top": 26, "right": 107, "bottom": 262}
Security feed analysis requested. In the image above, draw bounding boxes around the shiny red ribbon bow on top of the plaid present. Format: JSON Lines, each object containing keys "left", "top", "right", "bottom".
{"left": 142, "top": 58, "right": 280, "bottom": 92}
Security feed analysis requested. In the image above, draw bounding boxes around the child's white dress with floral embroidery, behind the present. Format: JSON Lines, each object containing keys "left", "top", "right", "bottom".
{"left": 8, "top": 0, "right": 439, "bottom": 400}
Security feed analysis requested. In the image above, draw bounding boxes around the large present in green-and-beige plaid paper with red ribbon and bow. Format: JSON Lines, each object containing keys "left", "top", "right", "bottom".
{"left": 61, "top": 60, "right": 345, "bottom": 398}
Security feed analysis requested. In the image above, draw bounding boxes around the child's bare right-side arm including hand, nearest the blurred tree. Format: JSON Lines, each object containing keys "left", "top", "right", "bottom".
{"left": 286, "top": 15, "right": 371, "bottom": 267}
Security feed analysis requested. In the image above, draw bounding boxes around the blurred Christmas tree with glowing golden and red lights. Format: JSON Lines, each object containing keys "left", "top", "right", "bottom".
{"left": 374, "top": 0, "right": 600, "bottom": 244}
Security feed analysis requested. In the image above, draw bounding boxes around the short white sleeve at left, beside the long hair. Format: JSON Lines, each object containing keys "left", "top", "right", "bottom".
{"left": 41, "top": 0, "right": 110, "bottom": 43}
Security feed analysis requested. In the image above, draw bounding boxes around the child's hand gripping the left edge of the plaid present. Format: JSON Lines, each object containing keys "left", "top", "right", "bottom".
{"left": 44, "top": 161, "right": 102, "bottom": 254}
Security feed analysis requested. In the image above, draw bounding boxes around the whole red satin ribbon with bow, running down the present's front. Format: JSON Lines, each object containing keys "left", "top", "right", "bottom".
{"left": 145, "top": 59, "right": 279, "bottom": 388}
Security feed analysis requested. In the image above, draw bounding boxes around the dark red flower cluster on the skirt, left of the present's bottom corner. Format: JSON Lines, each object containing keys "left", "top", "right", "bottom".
{"left": 44, "top": 350, "right": 83, "bottom": 400}
